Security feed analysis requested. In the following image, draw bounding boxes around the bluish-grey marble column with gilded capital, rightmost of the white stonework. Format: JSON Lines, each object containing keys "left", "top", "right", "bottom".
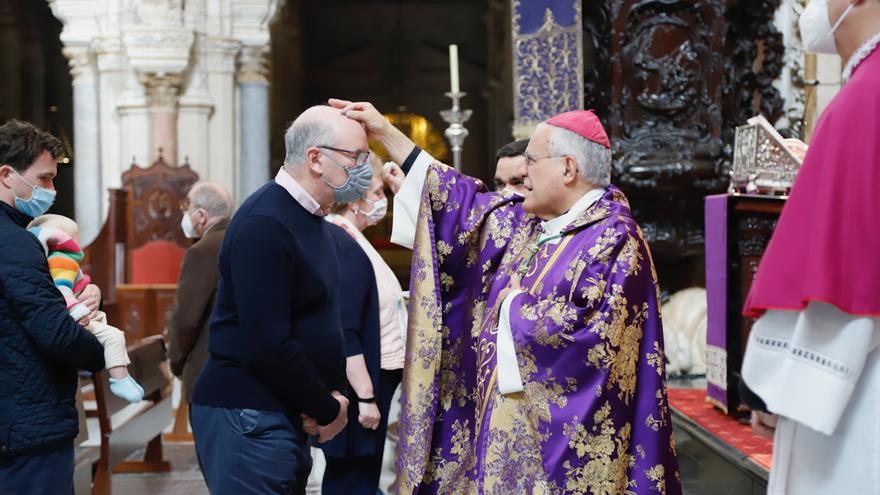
{"left": 238, "top": 46, "right": 270, "bottom": 200}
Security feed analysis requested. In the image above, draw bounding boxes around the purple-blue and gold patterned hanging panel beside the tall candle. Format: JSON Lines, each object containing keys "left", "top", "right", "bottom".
{"left": 511, "top": 0, "right": 584, "bottom": 139}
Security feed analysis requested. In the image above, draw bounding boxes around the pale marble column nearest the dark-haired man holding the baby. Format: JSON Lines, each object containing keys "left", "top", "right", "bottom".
{"left": 64, "top": 47, "right": 104, "bottom": 246}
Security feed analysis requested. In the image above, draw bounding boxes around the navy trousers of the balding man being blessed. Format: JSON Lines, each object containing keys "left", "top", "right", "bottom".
{"left": 190, "top": 404, "right": 312, "bottom": 495}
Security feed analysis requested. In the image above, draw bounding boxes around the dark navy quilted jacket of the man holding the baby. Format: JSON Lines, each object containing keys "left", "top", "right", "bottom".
{"left": 0, "top": 201, "right": 104, "bottom": 457}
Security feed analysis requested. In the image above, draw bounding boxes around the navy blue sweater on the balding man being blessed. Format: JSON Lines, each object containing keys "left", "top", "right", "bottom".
{"left": 193, "top": 182, "right": 346, "bottom": 425}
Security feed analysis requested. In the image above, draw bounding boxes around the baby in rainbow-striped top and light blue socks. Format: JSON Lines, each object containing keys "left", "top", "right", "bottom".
{"left": 28, "top": 215, "right": 144, "bottom": 402}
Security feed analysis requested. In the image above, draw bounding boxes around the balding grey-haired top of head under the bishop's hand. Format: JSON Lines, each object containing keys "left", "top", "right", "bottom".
{"left": 284, "top": 105, "right": 367, "bottom": 166}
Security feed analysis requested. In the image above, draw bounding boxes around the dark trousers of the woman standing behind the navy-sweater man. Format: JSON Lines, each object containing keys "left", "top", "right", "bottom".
{"left": 321, "top": 370, "right": 403, "bottom": 495}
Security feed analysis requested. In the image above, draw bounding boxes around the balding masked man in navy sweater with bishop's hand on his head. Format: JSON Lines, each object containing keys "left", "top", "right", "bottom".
{"left": 191, "top": 106, "right": 372, "bottom": 495}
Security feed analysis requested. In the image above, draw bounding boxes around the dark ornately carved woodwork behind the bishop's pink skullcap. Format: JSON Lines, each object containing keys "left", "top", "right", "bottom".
{"left": 583, "top": 0, "right": 784, "bottom": 280}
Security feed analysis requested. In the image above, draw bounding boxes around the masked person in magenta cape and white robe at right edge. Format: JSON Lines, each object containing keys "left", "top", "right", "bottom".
{"left": 742, "top": 0, "right": 880, "bottom": 495}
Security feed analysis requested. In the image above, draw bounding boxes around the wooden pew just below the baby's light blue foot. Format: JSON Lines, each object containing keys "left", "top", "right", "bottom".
{"left": 92, "top": 336, "right": 172, "bottom": 495}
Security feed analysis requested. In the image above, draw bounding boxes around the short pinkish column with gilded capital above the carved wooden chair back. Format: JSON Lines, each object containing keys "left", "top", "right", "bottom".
{"left": 141, "top": 74, "right": 183, "bottom": 166}
